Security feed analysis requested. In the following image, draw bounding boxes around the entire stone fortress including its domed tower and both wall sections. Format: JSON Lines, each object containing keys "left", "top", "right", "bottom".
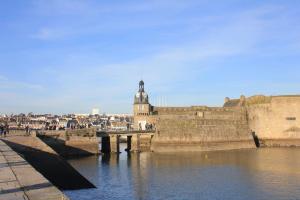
{"left": 134, "top": 81, "right": 300, "bottom": 152}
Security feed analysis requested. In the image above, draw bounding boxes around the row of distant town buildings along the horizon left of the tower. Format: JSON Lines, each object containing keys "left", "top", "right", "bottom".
{"left": 0, "top": 113, "right": 133, "bottom": 130}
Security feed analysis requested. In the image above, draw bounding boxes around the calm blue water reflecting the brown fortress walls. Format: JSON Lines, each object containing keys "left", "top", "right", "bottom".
{"left": 65, "top": 145, "right": 300, "bottom": 200}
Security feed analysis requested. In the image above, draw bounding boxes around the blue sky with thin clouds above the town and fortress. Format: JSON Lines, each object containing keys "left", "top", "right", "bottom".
{"left": 0, "top": 0, "right": 300, "bottom": 114}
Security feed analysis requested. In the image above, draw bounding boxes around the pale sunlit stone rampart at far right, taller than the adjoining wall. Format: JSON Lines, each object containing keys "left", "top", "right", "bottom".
{"left": 224, "top": 95, "right": 300, "bottom": 146}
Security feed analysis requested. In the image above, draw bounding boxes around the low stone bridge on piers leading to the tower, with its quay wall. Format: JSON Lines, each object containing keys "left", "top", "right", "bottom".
{"left": 37, "top": 128, "right": 155, "bottom": 156}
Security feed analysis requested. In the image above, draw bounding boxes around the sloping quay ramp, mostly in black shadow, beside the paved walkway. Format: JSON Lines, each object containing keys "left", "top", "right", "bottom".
{"left": 2, "top": 136, "right": 95, "bottom": 189}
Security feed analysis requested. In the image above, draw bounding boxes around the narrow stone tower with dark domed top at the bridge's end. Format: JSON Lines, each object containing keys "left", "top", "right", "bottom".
{"left": 133, "top": 80, "right": 151, "bottom": 130}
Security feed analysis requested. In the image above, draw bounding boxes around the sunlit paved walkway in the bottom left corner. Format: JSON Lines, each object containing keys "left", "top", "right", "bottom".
{"left": 0, "top": 140, "right": 68, "bottom": 200}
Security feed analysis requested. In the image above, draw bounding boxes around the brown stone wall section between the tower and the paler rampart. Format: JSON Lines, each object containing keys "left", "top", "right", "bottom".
{"left": 151, "top": 106, "right": 255, "bottom": 152}
